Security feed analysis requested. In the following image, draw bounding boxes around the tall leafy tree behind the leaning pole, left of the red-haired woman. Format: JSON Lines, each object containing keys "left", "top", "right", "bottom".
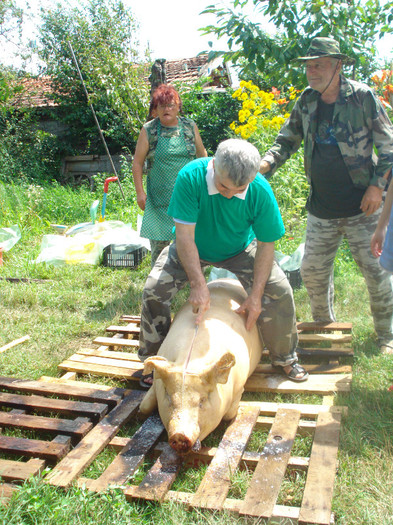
{"left": 39, "top": 0, "right": 149, "bottom": 153}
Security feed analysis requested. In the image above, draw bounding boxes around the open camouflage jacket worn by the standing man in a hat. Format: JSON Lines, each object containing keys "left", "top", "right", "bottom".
{"left": 263, "top": 76, "right": 393, "bottom": 188}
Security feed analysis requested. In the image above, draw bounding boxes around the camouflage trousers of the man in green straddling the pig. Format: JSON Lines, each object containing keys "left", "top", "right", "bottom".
{"left": 139, "top": 241, "right": 298, "bottom": 365}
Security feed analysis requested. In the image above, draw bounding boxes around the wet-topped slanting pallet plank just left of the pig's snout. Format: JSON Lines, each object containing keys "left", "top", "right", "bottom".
{"left": 89, "top": 414, "right": 164, "bottom": 491}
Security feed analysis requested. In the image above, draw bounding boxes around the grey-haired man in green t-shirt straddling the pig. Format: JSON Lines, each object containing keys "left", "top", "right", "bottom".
{"left": 139, "top": 139, "right": 308, "bottom": 387}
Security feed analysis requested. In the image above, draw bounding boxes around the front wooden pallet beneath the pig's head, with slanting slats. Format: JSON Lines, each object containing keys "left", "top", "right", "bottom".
{"left": 45, "top": 402, "right": 341, "bottom": 525}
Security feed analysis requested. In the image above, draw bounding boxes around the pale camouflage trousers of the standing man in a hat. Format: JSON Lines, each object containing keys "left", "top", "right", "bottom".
{"left": 301, "top": 210, "right": 393, "bottom": 340}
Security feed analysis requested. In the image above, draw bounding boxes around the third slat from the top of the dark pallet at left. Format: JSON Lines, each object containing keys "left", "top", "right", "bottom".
{"left": 0, "top": 412, "right": 93, "bottom": 439}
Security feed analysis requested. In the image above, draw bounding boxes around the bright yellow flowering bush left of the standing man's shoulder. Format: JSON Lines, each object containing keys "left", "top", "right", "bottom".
{"left": 229, "top": 80, "right": 297, "bottom": 139}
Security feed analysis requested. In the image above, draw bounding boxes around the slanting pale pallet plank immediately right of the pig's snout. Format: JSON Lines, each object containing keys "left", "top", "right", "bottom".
{"left": 192, "top": 405, "right": 259, "bottom": 510}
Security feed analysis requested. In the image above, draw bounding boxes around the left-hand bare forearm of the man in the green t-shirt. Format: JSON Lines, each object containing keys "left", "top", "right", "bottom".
{"left": 175, "top": 221, "right": 210, "bottom": 324}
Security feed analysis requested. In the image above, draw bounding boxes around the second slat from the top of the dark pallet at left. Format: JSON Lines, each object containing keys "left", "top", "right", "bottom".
{"left": 0, "top": 392, "right": 108, "bottom": 420}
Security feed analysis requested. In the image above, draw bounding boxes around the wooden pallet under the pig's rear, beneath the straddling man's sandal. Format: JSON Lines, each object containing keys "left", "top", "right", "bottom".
{"left": 59, "top": 316, "right": 353, "bottom": 395}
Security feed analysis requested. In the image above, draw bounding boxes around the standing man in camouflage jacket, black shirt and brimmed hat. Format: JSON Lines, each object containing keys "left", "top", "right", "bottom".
{"left": 260, "top": 37, "right": 393, "bottom": 353}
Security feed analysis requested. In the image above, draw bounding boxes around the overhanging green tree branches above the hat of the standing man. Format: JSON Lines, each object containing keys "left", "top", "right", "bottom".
{"left": 203, "top": 0, "right": 393, "bottom": 87}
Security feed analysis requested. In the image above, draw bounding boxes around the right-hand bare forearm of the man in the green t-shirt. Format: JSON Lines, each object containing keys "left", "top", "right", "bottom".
{"left": 236, "top": 241, "right": 274, "bottom": 330}
